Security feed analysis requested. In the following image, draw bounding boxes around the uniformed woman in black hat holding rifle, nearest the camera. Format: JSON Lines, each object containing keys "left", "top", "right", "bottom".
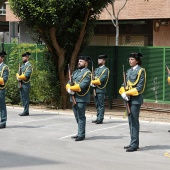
{"left": 119, "top": 53, "right": 146, "bottom": 152}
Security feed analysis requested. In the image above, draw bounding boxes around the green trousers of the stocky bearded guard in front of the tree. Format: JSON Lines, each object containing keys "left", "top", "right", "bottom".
{"left": 73, "top": 102, "right": 87, "bottom": 137}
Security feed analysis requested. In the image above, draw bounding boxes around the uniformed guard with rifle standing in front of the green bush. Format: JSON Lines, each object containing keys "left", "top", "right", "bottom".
{"left": 16, "top": 52, "right": 33, "bottom": 116}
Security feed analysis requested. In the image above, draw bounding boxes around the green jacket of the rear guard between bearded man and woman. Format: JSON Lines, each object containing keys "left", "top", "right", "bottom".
{"left": 94, "top": 66, "right": 109, "bottom": 93}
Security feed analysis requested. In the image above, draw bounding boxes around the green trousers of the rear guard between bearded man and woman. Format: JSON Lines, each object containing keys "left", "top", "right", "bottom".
{"left": 94, "top": 93, "right": 105, "bottom": 121}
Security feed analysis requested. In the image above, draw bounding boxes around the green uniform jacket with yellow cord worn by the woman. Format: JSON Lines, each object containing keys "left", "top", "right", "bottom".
{"left": 126, "top": 66, "right": 146, "bottom": 104}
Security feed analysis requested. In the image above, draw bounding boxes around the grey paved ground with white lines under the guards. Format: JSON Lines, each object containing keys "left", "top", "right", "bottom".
{"left": 0, "top": 106, "right": 170, "bottom": 170}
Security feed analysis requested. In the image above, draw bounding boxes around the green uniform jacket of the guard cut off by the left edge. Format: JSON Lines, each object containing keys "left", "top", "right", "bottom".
{"left": 0, "top": 63, "right": 9, "bottom": 93}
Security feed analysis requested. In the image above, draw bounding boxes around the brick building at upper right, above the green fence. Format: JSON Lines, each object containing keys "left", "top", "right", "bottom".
{"left": 91, "top": 0, "right": 170, "bottom": 46}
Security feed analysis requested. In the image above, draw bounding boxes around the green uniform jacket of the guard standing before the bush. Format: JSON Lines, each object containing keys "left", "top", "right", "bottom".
{"left": 21, "top": 62, "right": 33, "bottom": 88}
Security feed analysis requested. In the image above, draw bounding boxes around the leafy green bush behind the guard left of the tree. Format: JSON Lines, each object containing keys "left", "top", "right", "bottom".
{"left": 6, "top": 41, "right": 61, "bottom": 108}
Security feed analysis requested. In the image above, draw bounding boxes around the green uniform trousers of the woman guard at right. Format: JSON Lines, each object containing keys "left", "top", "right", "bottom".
{"left": 128, "top": 104, "right": 141, "bottom": 148}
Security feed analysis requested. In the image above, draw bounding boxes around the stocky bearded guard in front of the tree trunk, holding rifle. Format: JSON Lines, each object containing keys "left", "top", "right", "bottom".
{"left": 66, "top": 56, "right": 91, "bottom": 141}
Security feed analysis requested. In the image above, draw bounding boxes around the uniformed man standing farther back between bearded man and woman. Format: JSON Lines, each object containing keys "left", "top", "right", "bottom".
{"left": 91, "top": 54, "right": 109, "bottom": 124}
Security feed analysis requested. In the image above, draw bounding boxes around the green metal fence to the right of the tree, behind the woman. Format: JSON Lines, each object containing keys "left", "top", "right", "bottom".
{"left": 82, "top": 46, "right": 170, "bottom": 103}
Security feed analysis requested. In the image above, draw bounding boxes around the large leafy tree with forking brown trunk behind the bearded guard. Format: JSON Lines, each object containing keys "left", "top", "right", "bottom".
{"left": 9, "top": 0, "right": 111, "bottom": 108}
